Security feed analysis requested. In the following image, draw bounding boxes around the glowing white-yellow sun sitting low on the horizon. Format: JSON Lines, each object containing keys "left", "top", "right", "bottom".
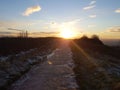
{"left": 60, "top": 28, "right": 75, "bottom": 39}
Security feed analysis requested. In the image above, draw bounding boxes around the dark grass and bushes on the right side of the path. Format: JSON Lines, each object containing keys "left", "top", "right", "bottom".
{"left": 70, "top": 36, "right": 120, "bottom": 90}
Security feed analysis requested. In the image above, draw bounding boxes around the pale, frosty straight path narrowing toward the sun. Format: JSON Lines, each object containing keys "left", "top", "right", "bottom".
{"left": 10, "top": 45, "right": 78, "bottom": 90}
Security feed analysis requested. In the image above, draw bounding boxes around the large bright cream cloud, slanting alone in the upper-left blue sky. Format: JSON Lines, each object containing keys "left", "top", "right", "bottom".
{"left": 22, "top": 6, "right": 42, "bottom": 16}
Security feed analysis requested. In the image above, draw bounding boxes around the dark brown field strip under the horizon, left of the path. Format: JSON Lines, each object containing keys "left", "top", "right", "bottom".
{"left": 0, "top": 38, "right": 61, "bottom": 56}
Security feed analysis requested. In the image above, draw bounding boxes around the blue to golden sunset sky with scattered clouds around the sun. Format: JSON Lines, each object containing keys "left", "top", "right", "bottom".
{"left": 0, "top": 0, "right": 120, "bottom": 39}
